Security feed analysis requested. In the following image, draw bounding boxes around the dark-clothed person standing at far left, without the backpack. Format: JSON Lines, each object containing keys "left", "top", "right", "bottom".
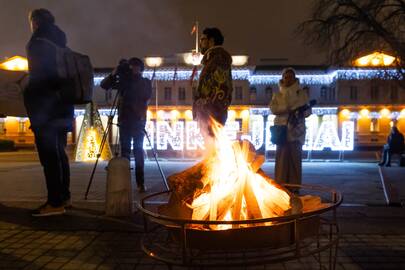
{"left": 24, "top": 9, "right": 74, "bottom": 216}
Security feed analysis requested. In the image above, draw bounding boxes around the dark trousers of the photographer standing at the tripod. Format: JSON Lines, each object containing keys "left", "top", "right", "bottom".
{"left": 120, "top": 120, "right": 146, "bottom": 186}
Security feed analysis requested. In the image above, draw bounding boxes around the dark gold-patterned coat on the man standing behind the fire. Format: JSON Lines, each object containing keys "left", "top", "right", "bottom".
{"left": 193, "top": 46, "right": 233, "bottom": 124}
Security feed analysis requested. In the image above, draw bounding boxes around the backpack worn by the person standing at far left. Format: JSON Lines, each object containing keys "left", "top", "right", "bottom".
{"left": 38, "top": 38, "right": 94, "bottom": 104}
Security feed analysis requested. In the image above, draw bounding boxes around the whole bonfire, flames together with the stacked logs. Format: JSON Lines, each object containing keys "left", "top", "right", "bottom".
{"left": 159, "top": 119, "right": 323, "bottom": 230}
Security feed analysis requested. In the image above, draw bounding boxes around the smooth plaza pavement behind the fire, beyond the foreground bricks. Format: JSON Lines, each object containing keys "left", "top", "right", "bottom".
{"left": 0, "top": 161, "right": 386, "bottom": 205}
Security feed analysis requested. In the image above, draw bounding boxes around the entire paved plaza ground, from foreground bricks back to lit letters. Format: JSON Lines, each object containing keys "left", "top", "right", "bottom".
{"left": 0, "top": 152, "right": 405, "bottom": 269}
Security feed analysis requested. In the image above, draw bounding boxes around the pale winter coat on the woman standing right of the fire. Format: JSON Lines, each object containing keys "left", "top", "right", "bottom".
{"left": 270, "top": 80, "right": 310, "bottom": 144}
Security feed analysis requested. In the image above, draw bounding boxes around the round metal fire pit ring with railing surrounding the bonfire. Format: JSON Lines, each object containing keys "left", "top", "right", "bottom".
{"left": 137, "top": 184, "right": 343, "bottom": 269}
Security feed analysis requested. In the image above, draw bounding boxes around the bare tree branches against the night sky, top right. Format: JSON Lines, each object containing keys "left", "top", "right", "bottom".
{"left": 297, "top": 0, "right": 405, "bottom": 89}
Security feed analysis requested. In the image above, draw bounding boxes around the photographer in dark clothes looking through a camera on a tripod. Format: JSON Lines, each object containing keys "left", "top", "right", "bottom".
{"left": 100, "top": 57, "right": 152, "bottom": 192}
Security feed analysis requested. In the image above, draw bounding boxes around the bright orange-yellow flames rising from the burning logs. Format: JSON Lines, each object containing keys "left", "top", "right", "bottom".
{"left": 191, "top": 118, "right": 291, "bottom": 230}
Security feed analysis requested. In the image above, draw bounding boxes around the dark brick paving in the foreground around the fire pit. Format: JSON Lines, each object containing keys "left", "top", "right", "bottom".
{"left": 0, "top": 202, "right": 405, "bottom": 270}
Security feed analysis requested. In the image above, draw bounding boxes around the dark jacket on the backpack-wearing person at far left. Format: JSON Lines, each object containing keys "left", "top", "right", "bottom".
{"left": 23, "top": 24, "right": 74, "bottom": 131}
